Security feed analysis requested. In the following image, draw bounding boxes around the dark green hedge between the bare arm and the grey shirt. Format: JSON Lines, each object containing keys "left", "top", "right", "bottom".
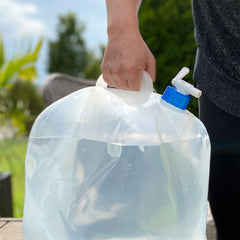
{"left": 139, "top": 0, "right": 197, "bottom": 115}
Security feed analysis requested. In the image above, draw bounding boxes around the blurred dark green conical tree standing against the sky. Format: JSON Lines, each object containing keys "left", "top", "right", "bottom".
{"left": 48, "top": 13, "right": 87, "bottom": 77}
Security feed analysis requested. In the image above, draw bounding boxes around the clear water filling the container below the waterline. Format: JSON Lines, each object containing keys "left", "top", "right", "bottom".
{"left": 24, "top": 137, "right": 209, "bottom": 240}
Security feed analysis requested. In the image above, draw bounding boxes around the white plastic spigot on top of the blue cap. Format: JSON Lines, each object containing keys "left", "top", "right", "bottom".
{"left": 172, "top": 67, "right": 202, "bottom": 98}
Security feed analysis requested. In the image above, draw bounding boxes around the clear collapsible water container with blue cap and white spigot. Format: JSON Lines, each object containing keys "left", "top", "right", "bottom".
{"left": 23, "top": 68, "right": 210, "bottom": 240}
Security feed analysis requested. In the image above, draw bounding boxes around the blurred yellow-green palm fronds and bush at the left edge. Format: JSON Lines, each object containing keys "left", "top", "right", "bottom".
{"left": 0, "top": 37, "right": 43, "bottom": 135}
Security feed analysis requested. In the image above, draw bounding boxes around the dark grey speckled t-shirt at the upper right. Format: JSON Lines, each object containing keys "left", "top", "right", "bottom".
{"left": 192, "top": 0, "right": 240, "bottom": 117}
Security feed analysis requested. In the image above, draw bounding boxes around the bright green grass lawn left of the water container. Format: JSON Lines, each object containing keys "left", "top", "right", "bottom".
{"left": 0, "top": 139, "right": 27, "bottom": 218}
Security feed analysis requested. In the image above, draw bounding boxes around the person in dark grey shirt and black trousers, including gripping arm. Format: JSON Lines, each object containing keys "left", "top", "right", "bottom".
{"left": 101, "top": 0, "right": 240, "bottom": 240}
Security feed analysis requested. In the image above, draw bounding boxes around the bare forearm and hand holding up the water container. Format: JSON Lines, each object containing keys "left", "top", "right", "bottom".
{"left": 101, "top": 0, "right": 155, "bottom": 91}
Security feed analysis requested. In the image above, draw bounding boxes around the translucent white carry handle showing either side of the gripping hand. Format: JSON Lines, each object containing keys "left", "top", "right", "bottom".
{"left": 96, "top": 71, "right": 153, "bottom": 92}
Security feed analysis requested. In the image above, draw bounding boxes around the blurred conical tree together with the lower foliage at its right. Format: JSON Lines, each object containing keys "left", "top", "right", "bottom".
{"left": 48, "top": 12, "right": 102, "bottom": 79}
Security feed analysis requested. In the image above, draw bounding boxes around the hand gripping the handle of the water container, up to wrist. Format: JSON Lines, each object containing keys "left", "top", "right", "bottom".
{"left": 101, "top": 28, "right": 156, "bottom": 91}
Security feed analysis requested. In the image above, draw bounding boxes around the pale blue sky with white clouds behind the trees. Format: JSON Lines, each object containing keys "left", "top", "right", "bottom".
{"left": 0, "top": 0, "right": 107, "bottom": 85}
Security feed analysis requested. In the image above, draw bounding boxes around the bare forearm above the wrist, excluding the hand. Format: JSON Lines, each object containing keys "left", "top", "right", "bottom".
{"left": 106, "top": 0, "right": 141, "bottom": 35}
